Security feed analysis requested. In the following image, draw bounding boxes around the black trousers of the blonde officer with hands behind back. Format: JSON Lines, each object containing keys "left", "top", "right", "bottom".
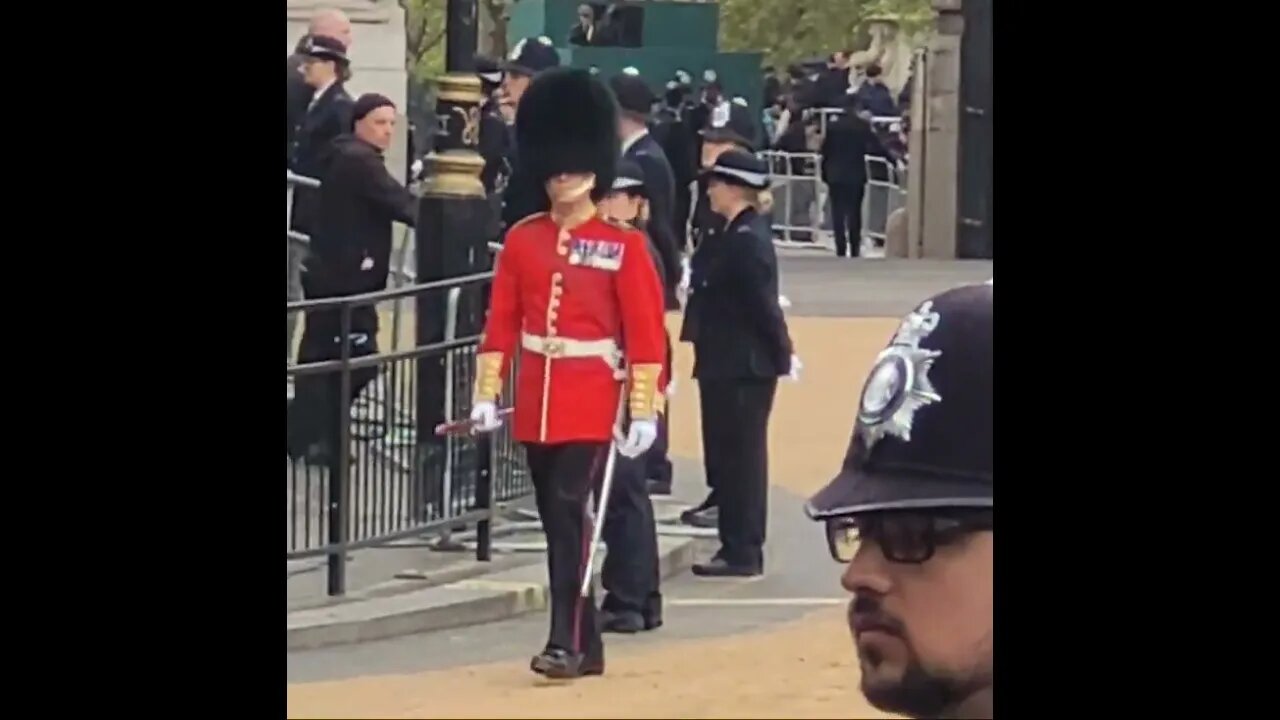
{"left": 698, "top": 378, "right": 778, "bottom": 568}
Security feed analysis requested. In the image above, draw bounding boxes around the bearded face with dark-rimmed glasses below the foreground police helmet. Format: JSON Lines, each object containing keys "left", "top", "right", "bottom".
{"left": 841, "top": 512, "right": 995, "bottom": 717}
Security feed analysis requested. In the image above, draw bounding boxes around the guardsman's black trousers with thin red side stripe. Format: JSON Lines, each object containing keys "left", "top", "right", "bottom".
{"left": 525, "top": 442, "right": 609, "bottom": 661}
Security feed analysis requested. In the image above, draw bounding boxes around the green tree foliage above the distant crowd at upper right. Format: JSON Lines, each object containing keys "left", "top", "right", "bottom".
{"left": 719, "top": 0, "right": 932, "bottom": 68}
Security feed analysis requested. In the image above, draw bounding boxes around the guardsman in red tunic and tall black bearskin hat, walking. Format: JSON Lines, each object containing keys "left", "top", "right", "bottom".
{"left": 471, "top": 68, "right": 667, "bottom": 678}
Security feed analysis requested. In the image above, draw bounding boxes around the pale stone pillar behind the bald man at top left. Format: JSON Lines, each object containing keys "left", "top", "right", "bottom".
{"left": 285, "top": 0, "right": 408, "bottom": 181}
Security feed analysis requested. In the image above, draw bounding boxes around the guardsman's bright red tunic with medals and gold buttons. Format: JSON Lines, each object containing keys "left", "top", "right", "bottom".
{"left": 480, "top": 213, "right": 667, "bottom": 445}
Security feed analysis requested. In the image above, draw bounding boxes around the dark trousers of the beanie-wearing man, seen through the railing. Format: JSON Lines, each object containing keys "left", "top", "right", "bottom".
{"left": 285, "top": 306, "right": 378, "bottom": 459}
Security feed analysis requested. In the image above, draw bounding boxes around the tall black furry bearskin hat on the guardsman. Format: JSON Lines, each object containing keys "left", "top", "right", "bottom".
{"left": 516, "top": 68, "right": 622, "bottom": 201}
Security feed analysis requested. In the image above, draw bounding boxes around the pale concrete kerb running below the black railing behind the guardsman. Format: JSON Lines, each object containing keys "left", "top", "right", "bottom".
{"left": 287, "top": 536, "right": 707, "bottom": 651}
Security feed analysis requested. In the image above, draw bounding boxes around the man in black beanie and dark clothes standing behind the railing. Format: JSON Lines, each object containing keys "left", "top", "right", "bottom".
{"left": 287, "top": 94, "right": 417, "bottom": 461}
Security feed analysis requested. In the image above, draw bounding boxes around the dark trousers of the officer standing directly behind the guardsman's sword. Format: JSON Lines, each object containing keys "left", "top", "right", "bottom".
{"left": 600, "top": 455, "right": 662, "bottom": 621}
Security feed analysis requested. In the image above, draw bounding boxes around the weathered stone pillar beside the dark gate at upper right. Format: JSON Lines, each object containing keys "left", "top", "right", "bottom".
{"left": 909, "top": 0, "right": 964, "bottom": 259}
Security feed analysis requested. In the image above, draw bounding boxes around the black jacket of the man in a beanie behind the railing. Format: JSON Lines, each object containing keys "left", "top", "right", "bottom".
{"left": 303, "top": 135, "right": 417, "bottom": 297}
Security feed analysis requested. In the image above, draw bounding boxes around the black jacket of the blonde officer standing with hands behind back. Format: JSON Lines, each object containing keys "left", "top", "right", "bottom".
{"left": 680, "top": 209, "right": 792, "bottom": 380}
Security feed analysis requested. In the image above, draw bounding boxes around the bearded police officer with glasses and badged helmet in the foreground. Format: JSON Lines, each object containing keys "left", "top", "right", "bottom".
{"left": 805, "top": 281, "right": 995, "bottom": 717}
